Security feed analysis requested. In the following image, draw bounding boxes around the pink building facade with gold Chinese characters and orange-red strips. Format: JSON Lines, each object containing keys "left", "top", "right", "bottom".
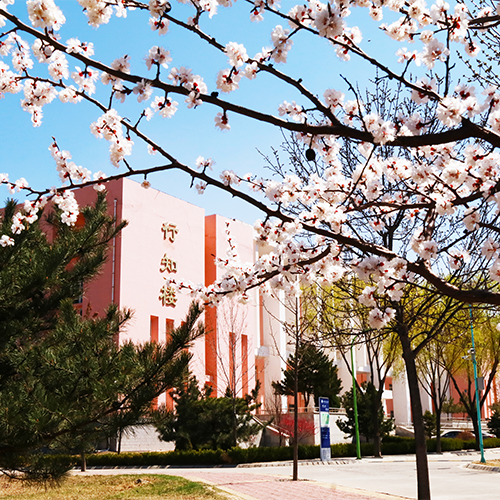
{"left": 76, "top": 179, "right": 258, "bottom": 406}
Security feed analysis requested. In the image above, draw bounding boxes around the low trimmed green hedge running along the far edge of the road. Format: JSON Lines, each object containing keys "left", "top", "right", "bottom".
{"left": 64, "top": 436, "right": 500, "bottom": 467}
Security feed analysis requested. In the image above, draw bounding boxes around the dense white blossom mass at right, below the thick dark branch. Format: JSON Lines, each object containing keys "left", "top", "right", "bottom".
{"left": 169, "top": 123, "right": 500, "bottom": 328}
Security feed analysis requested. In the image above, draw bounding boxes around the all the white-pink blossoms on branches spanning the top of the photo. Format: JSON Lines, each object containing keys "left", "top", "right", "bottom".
{"left": 0, "top": 0, "right": 500, "bottom": 328}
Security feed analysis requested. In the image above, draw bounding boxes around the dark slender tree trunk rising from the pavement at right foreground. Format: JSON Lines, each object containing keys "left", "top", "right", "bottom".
{"left": 396, "top": 314, "right": 431, "bottom": 500}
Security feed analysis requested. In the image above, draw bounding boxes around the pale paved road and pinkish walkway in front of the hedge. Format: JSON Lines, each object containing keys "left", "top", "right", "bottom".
{"left": 78, "top": 449, "right": 500, "bottom": 500}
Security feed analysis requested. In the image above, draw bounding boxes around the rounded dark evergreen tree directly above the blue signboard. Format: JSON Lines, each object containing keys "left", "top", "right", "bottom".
{"left": 272, "top": 343, "right": 342, "bottom": 408}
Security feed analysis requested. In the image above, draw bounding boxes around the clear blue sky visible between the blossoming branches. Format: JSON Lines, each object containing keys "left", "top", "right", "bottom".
{"left": 0, "top": 1, "right": 426, "bottom": 223}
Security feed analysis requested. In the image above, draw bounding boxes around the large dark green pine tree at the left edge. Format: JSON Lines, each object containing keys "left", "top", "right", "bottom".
{"left": 0, "top": 195, "right": 203, "bottom": 480}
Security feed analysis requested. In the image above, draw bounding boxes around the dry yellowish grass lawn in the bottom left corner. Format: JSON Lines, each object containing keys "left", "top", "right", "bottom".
{"left": 0, "top": 475, "right": 227, "bottom": 500}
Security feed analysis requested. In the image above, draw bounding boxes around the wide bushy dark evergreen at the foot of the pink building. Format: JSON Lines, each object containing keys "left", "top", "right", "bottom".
{"left": 153, "top": 375, "right": 260, "bottom": 450}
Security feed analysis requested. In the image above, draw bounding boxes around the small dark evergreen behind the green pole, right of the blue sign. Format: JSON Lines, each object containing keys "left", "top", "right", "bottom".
{"left": 337, "top": 382, "right": 394, "bottom": 441}
